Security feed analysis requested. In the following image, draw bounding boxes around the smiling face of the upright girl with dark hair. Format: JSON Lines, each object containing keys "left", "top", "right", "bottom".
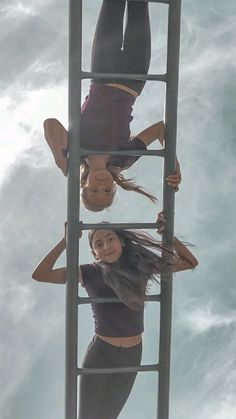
{"left": 91, "top": 230, "right": 122, "bottom": 263}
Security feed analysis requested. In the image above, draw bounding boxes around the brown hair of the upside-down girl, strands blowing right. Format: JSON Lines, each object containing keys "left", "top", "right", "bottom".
{"left": 80, "top": 162, "right": 157, "bottom": 211}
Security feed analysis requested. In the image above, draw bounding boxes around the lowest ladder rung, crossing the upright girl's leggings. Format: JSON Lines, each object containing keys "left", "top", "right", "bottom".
{"left": 77, "top": 364, "right": 159, "bottom": 375}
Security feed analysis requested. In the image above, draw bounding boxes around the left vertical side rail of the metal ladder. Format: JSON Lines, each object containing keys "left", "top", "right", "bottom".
{"left": 65, "top": 0, "right": 82, "bottom": 419}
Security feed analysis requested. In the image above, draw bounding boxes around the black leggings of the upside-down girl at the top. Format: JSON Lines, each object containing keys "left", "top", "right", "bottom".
{"left": 91, "top": 0, "right": 151, "bottom": 94}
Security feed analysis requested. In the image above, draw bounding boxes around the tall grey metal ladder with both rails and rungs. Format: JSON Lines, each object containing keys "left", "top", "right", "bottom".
{"left": 65, "top": 0, "right": 181, "bottom": 419}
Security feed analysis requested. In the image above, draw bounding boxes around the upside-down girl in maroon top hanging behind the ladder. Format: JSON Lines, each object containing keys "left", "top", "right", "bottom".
{"left": 44, "top": 0, "right": 181, "bottom": 211}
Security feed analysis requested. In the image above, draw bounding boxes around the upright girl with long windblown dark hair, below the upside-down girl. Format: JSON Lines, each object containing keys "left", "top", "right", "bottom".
{"left": 32, "top": 213, "right": 197, "bottom": 419}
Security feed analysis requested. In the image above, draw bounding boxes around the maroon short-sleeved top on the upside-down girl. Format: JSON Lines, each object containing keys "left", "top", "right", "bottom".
{"left": 81, "top": 84, "right": 146, "bottom": 170}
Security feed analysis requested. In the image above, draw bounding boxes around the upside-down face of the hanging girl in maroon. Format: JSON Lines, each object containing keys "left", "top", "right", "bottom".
{"left": 83, "top": 170, "right": 116, "bottom": 211}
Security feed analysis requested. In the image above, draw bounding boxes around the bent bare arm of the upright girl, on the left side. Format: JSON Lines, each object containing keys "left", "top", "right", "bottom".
{"left": 32, "top": 238, "right": 81, "bottom": 284}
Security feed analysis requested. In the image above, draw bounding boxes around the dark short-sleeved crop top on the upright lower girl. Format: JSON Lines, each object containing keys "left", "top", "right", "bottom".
{"left": 80, "top": 263, "right": 144, "bottom": 337}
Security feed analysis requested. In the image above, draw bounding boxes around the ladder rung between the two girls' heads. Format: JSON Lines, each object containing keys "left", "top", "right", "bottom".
{"left": 79, "top": 221, "right": 157, "bottom": 230}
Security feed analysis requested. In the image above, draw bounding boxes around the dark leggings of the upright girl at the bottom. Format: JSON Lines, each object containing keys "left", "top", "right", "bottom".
{"left": 78, "top": 336, "right": 142, "bottom": 419}
